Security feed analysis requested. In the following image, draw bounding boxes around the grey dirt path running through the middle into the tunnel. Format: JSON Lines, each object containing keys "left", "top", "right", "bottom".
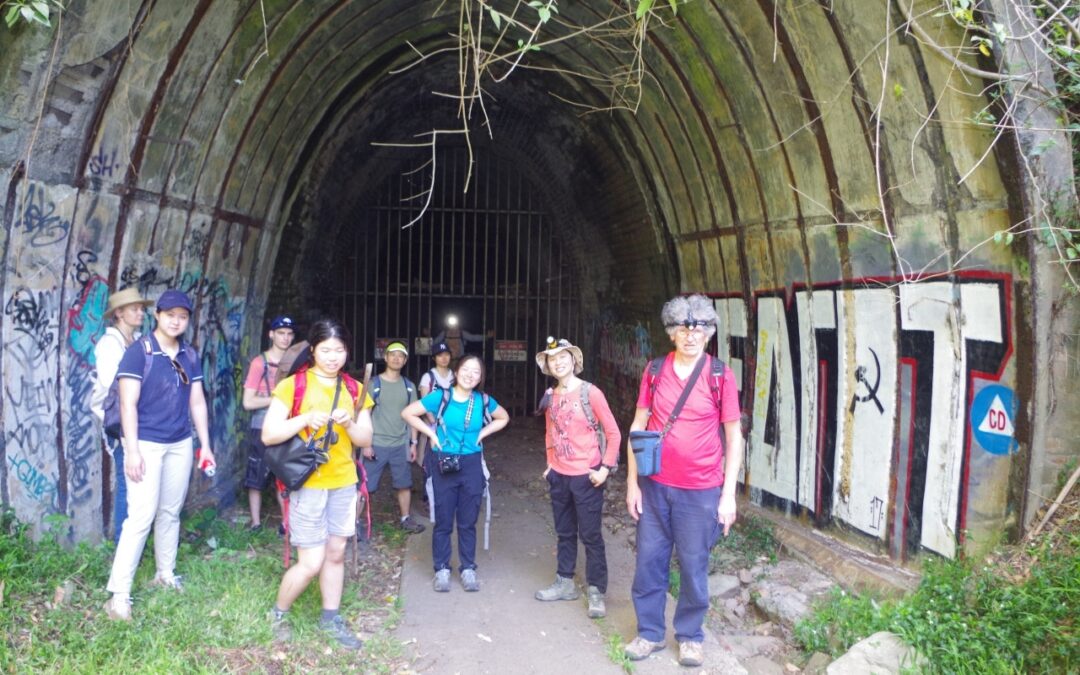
{"left": 396, "top": 420, "right": 741, "bottom": 674}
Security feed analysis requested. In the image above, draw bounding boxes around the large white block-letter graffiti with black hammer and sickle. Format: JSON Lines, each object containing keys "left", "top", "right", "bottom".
{"left": 715, "top": 273, "right": 1012, "bottom": 556}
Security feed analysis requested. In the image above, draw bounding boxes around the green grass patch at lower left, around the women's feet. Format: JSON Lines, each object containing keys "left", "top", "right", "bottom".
{"left": 0, "top": 511, "right": 402, "bottom": 673}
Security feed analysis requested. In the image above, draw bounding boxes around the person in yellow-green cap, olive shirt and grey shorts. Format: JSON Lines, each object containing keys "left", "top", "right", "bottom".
{"left": 361, "top": 341, "right": 423, "bottom": 534}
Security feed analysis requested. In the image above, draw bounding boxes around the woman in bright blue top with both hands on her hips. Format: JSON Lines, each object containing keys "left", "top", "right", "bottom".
{"left": 402, "top": 354, "right": 510, "bottom": 593}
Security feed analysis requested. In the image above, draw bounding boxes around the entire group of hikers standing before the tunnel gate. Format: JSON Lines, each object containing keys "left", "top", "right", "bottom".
{"left": 91, "top": 288, "right": 743, "bottom": 666}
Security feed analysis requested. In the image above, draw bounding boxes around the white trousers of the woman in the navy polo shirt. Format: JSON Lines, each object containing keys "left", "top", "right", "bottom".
{"left": 106, "top": 438, "right": 194, "bottom": 593}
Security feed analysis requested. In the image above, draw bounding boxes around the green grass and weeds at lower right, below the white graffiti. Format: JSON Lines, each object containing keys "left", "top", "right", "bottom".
{"left": 795, "top": 535, "right": 1080, "bottom": 673}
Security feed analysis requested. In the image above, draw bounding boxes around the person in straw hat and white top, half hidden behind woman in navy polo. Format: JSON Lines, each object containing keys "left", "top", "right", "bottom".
{"left": 90, "top": 288, "right": 153, "bottom": 543}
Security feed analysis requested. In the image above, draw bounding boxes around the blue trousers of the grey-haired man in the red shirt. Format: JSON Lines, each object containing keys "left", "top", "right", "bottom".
{"left": 631, "top": 477, "right": 720, "bottom": 643}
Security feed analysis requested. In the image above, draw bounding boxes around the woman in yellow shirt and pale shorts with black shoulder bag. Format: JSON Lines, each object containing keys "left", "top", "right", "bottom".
{"left": 262, "top": 319, "right": 373, "bottom": 649}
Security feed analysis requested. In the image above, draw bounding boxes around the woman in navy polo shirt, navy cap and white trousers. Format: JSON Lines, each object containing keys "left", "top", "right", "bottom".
{"left": 105, "top": 291, "right": 214, "bottom": 621}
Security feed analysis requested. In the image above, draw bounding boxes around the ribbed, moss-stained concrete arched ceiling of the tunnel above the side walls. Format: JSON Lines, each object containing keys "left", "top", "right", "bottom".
{"left": 48, "top": 0, "right": 1005, "bottom": 291}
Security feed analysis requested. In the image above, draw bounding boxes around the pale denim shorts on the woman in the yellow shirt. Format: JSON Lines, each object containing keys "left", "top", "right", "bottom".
{"left": 288, "top": 485, "right": 356, "bottom": 549}
